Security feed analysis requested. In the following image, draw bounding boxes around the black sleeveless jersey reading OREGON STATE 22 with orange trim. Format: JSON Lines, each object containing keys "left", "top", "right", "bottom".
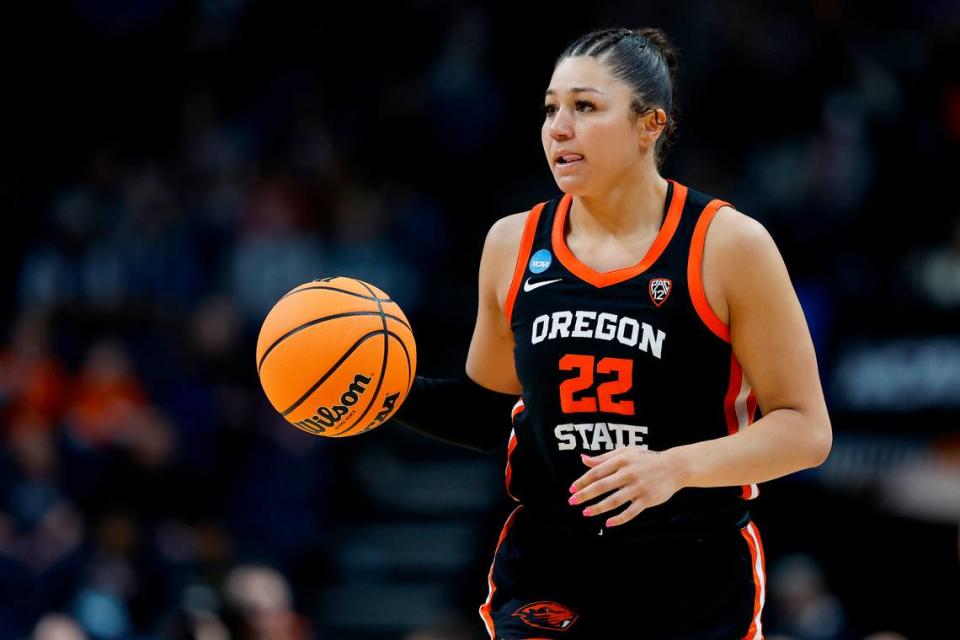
{"left": 506, "top": 181, "right": 757, "bottom": 539}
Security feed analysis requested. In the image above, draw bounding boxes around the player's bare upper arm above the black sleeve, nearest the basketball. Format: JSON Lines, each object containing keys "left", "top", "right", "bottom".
{"left": 466, "top": 213, "right": 527, "bottom": 394}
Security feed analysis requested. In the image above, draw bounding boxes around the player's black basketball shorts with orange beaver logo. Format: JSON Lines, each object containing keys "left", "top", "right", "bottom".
{"left": 480, "top": 506, "right": 765, "bottom": 640}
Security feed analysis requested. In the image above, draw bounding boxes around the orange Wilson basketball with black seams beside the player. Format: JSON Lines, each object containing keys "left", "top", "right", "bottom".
{"left": 257, "top": 277, "right": 417, "bottom": 437}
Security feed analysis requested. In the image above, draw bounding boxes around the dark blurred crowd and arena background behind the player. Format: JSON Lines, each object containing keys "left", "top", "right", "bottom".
{"left": 0, "top": 0, "right": 960, "bottom": 640}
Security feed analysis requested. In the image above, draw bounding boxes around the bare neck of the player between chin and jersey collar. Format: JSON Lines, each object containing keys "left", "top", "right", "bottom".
{"left": 570, "top": 167, "right": 667, "bottom": 235}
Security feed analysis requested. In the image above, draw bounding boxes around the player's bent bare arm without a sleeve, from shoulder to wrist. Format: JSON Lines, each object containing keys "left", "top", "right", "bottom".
{"left": 665, "top": 207, "right": 832, "bottom": 487}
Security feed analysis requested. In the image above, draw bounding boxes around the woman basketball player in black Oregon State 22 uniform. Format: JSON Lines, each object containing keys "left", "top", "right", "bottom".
{"left": 397, "top": 29, "right": 831, "bottom": 640}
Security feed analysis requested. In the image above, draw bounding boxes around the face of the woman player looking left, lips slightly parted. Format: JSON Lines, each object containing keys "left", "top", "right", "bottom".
{"left": 540, "top": 56, "right": 656, "bottom": 196}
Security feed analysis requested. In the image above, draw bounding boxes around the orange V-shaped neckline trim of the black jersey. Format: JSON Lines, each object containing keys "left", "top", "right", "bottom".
{"left": 551, "top": 180, "right": 687, "bottom": 287}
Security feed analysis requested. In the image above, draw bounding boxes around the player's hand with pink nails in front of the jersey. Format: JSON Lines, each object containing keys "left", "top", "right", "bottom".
{"left": 570, "top": 446, "right": 682, "bottom": 527}
